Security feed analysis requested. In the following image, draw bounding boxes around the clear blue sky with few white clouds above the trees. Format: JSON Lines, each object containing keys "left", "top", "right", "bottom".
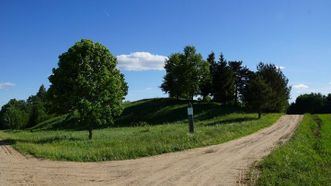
{"left": 0, "top": 0, "right": 331, "bottom": 105}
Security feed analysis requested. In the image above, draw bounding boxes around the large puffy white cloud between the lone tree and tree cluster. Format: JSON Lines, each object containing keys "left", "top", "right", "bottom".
{"left": 116, "top": 52, "right": 168, "bottom": 71}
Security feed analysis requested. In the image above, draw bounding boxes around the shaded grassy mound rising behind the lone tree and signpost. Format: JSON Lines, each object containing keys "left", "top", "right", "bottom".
{"left": 30, "top": 98, "right": 240, "bottom": 130}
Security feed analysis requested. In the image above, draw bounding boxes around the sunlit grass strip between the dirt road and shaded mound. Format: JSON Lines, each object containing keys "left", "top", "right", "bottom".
{"left": 0, "top": 113, "right": 281, "bottom": 161}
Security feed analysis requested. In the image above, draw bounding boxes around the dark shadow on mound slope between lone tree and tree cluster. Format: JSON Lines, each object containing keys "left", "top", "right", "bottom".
{"left": 115, "top": 98, "right": 240, "bottom": 127}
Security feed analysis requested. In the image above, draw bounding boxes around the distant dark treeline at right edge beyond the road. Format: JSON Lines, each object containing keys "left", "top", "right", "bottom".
{"left": 287, "top": 93, "right": 331, "bottom": 114}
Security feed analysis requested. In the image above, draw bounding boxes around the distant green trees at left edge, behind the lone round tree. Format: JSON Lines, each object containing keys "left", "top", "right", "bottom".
{"left": 0, "top": 85, "right": 51, "bottom": 129}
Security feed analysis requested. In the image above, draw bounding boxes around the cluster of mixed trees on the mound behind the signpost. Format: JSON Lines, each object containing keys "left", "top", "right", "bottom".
{"left": 161, "top": 46, "right": 291, "bottom": 117}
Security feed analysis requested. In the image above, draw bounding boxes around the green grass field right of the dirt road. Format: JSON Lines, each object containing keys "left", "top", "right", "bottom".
{"left": 257, "top": 115, "right": 331, "bottom": 186}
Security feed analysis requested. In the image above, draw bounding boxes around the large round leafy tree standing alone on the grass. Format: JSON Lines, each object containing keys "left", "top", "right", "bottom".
{"left": 49, "top": 40, "right": 128, "bottom": 139}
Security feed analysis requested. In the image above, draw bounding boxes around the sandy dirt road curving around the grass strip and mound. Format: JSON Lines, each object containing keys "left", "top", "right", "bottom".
{"left": 0, "top": 115, "right": 303, "bottom": 186}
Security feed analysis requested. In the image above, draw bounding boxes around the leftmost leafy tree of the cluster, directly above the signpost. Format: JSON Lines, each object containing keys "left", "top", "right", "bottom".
{"left": 161, "top": 46, "right": 208, "bottom": 100}
